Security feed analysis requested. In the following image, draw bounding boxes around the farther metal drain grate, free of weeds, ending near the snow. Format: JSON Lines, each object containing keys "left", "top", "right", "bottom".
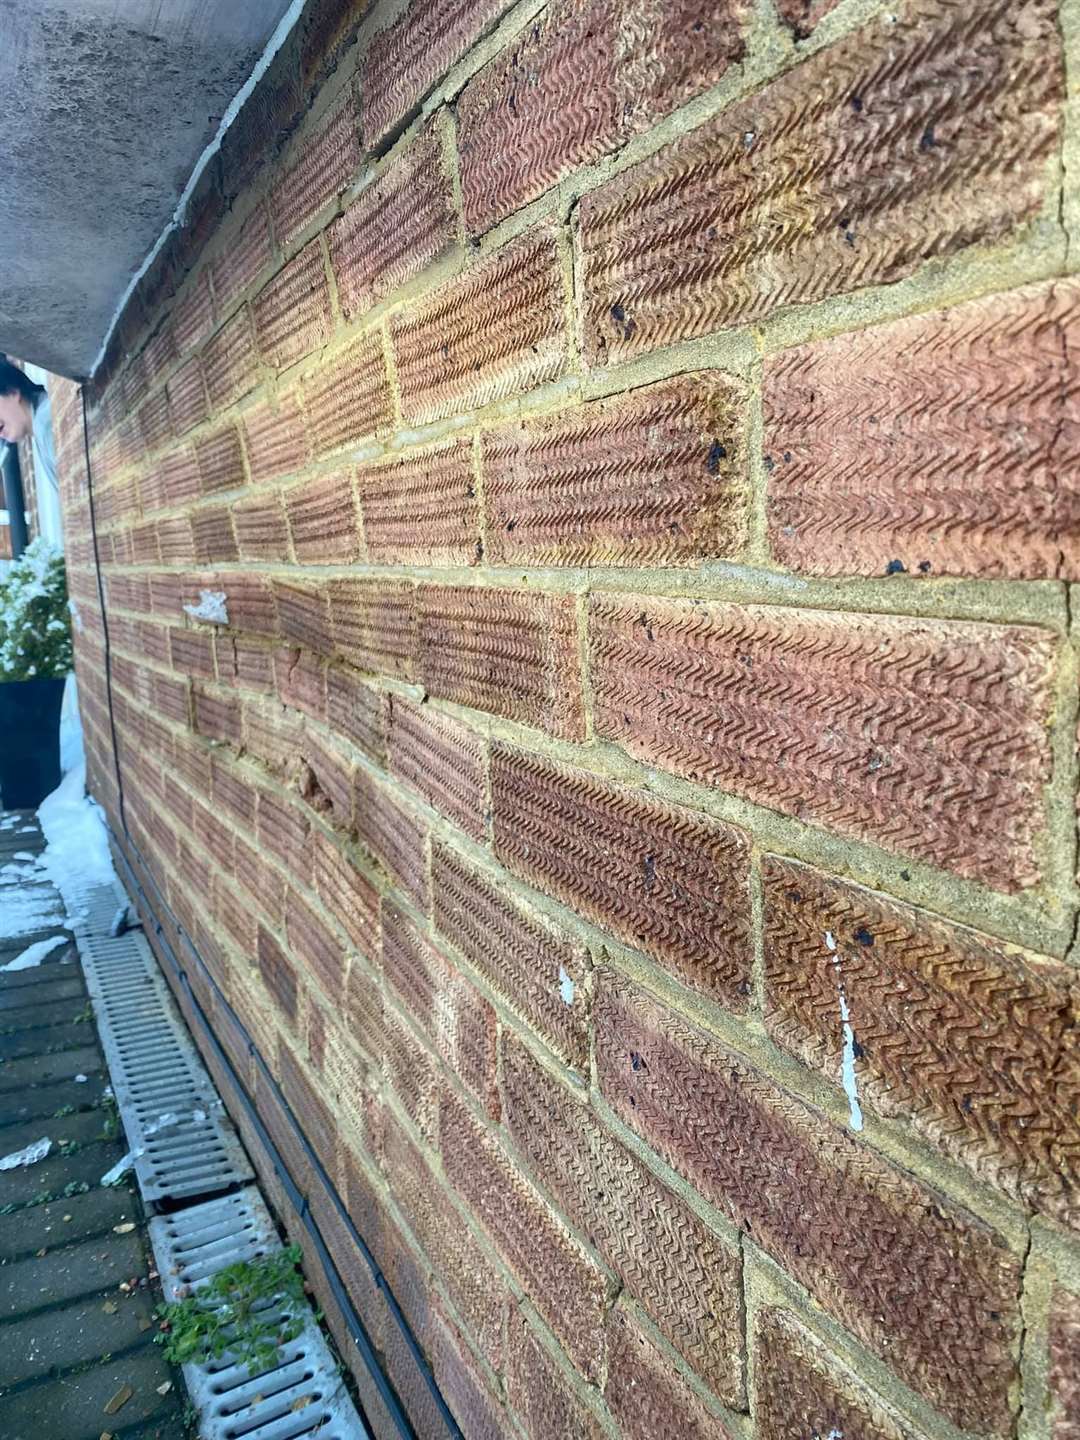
{"left": 75, "top": 886, "right": 253, "bottom": 1202}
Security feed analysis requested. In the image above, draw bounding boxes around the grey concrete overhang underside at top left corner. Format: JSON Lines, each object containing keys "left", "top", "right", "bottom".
{"left": 0, "top": 0, "right": 288, "bottom": 376}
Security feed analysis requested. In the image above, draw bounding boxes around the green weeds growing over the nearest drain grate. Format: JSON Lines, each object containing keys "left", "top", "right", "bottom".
{"left": 157, "top": 1246, "right": 304, "bottom": 1372}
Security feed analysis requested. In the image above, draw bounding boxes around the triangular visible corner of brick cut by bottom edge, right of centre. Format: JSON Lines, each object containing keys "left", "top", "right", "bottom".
{"left": 753, "top": 1309, "right": 919, "bottom": 1440}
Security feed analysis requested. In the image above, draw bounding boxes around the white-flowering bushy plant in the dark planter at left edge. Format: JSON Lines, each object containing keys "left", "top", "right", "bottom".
{"left": 0, "top": 536, "right": 72, "bottom": 684}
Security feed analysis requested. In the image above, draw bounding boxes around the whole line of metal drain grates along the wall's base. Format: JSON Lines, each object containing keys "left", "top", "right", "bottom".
{"left": 69, "top": 884, "right": 370, "bottom": 1440}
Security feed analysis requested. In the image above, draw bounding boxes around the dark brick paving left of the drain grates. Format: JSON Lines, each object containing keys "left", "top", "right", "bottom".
{"left": 0, "top": 815, "right": 187, "bottom": 1440}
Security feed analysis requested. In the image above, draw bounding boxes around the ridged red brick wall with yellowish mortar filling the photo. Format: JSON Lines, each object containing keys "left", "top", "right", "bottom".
{"left": 55, "top": 0, "right": 1080, "bottom": 1440}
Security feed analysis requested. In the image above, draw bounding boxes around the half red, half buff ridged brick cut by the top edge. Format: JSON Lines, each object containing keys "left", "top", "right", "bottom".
{"left": 458, "top": 0, "right": 749, "bottom": 230}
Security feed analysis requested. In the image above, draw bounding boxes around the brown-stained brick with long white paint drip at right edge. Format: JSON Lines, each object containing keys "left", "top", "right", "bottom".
{"left": 763, "top": 857, "right": 1080, "bottom": 1228}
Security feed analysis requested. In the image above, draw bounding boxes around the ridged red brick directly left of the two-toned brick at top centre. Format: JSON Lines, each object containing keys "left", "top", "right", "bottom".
{"left": 327, "top": 128, "right": 456, "bottom": 320}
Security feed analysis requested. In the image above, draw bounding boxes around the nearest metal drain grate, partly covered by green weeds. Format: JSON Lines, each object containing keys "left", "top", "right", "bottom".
{"left": 150, "top": 1187, "right": 370, "bottom": 1440}
